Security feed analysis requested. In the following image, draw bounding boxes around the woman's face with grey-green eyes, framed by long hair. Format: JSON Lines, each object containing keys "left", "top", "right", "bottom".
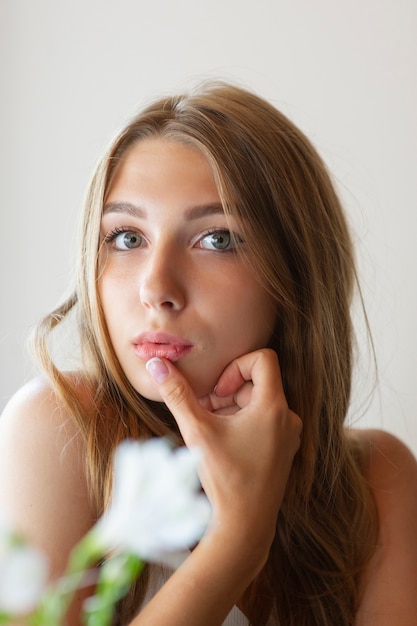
{"left": 99, "top": 139, "right": 276, "bottom": 400}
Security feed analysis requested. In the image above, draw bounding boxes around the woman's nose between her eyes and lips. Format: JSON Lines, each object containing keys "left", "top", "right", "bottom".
{"left": 139, "top": 245, "right": 186, "bottom": 312}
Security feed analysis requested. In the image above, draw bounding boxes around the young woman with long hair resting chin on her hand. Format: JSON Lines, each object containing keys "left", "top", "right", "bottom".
{"left": 0, "top": 84, "right": 417, "bottom": 626}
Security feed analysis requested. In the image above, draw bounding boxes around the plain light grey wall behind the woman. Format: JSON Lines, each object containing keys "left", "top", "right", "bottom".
{"left": 0, "top": 0, "right": 417, "bottom": 451}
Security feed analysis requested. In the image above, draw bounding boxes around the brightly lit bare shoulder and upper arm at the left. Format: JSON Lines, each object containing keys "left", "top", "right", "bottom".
{"left": 0, "top": 378, "right": 94, "bottom": 573}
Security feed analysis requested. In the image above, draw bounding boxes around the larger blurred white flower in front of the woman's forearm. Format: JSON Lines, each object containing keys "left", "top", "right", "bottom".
{"left": 95, "top": 439, "right": 211, "bottom": 564}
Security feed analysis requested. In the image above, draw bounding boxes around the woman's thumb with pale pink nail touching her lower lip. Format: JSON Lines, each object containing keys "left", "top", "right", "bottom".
{"left": 146, "top": 357, "right": 202, "bottom": 436}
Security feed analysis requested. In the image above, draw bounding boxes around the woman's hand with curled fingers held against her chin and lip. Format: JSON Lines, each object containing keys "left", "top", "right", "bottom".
{"left": 148, "top": 349, "right": 301, "bottom": 558}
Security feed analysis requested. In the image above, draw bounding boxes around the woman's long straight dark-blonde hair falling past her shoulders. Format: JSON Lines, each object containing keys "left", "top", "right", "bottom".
{"left": 32, "top": 84, "right": 377, "bottom": 626}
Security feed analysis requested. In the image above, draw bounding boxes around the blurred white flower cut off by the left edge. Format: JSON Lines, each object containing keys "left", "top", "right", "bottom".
{"left": 0, "top": 515, "right": 48, "bottom": 615}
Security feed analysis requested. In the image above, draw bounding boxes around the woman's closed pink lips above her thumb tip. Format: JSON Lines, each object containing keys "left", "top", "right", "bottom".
{"left": 133, "top": 331, "right": 193, "bottom": 362}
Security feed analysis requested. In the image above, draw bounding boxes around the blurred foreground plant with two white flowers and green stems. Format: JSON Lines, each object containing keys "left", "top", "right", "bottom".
{"left": 0, "top": 439, "right": 211, "bottom": 626}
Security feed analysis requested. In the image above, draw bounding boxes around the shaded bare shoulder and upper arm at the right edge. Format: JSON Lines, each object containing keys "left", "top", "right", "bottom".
{"left": 352, "top": 430, "right": 417, "bottom": 626}
